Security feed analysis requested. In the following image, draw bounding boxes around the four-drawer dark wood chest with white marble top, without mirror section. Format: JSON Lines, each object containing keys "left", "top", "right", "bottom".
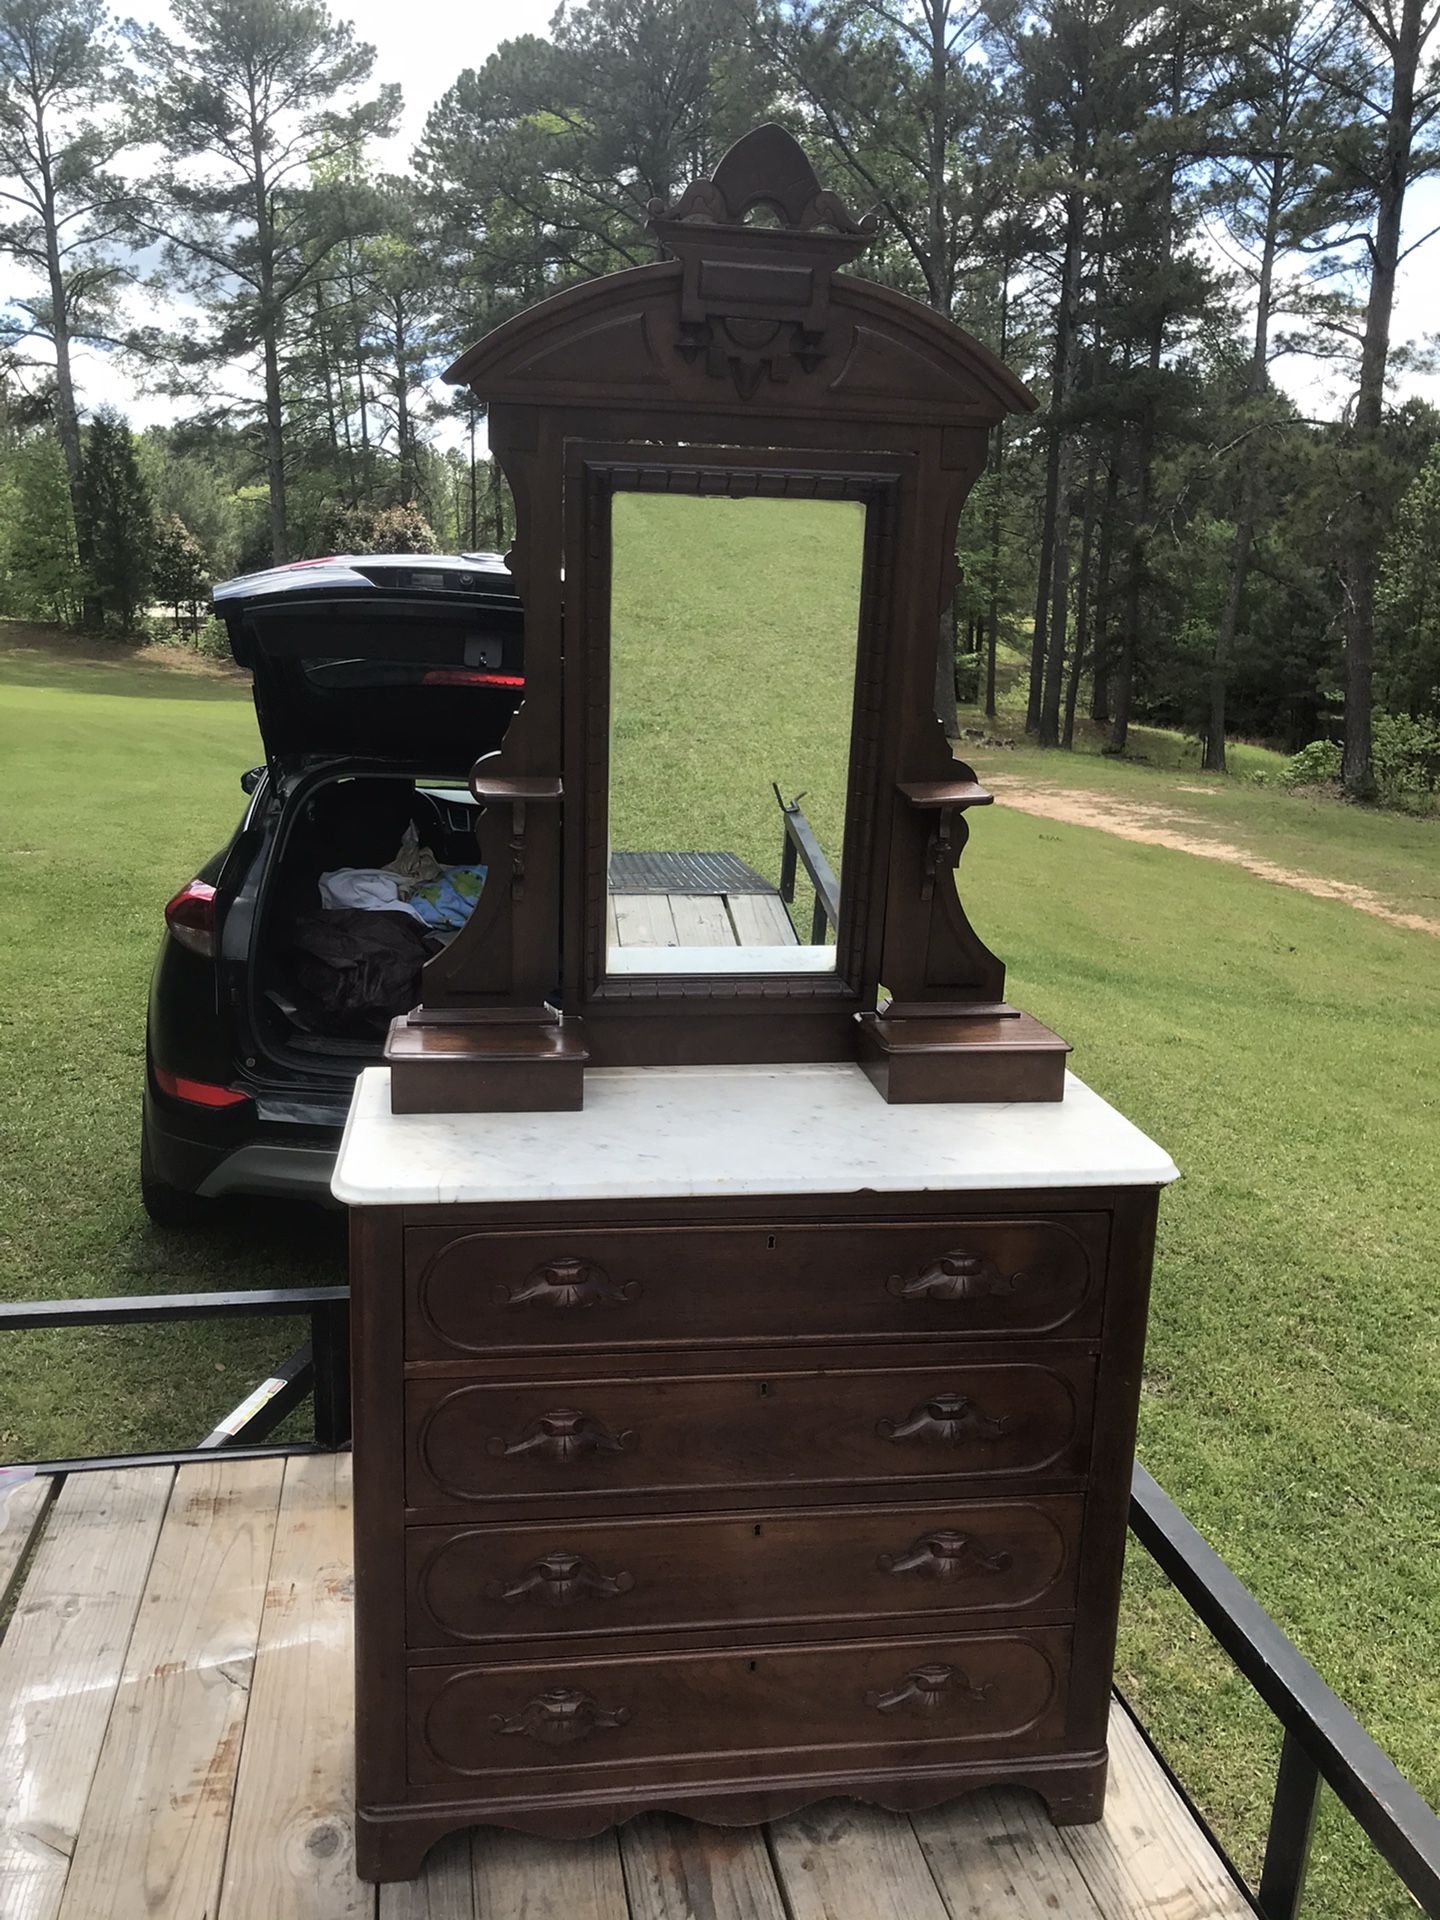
{"left": 336, "top": 1066, "right": 1175, "bottom": 1880}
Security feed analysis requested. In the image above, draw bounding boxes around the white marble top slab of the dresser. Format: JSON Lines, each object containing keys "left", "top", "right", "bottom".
{"left": 330, "top": 1066, "right": 1177, "bottom": 1206}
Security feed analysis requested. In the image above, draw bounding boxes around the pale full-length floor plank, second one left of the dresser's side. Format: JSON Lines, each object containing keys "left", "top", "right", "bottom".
{"left": 60, "top": 1455, "right": 284, "bottom": 1920}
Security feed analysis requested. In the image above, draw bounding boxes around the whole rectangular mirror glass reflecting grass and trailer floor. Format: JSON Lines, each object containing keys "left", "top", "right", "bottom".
{"left": 607, "top": 493, "right": 866, "bottom": 973}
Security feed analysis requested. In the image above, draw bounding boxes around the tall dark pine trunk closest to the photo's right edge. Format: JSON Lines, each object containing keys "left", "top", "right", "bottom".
{"left": 1340, "top": 0, "right": 1425, "bottom": 799}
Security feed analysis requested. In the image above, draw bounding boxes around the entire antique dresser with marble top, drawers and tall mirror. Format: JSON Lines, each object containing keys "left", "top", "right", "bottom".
{"left": 334, "top": 127, "right": 1175, "bottom": 1880}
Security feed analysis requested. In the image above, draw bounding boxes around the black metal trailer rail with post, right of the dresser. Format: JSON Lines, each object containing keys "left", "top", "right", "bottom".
{"left": 1131, "top": 1461, "right": 1440, "bottom": 1920}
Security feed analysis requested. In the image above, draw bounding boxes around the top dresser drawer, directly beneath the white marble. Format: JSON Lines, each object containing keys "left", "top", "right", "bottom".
{"left": 405, "top": 1213, "right": 1108, "bottom": 1359}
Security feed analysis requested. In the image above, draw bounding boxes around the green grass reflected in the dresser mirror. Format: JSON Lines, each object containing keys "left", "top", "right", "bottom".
{"left": 611, "top": 493, "right": 864, "bottom": 925}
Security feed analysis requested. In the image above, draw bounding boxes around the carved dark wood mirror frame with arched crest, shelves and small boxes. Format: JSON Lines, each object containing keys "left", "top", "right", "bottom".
{"left": 386, "top": 127, "right": 1066, "bottom": 1112}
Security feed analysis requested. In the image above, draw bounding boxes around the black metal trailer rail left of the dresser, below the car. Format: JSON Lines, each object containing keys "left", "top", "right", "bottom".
{"left": 0, "top": 1286, "right": 349, "bottom": 1473}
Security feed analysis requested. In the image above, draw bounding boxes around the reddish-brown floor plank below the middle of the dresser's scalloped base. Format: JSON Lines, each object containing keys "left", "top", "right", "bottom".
{"left": 620, "top": 1812, "right": 787, "bottom": 1920}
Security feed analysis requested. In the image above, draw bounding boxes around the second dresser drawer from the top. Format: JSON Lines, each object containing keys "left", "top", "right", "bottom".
{"left": 405, "top": 1354, "right": 1094, "bottom": 1511}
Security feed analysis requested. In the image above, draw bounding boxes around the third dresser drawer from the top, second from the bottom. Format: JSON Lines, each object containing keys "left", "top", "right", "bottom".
{"left": 405, "top": 1494, "right": 1083, "bottom": 1647}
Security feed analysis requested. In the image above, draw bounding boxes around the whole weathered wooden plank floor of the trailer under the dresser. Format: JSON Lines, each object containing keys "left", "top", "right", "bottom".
{"left": 0, "top": 1455, "right": 1250, "bottom": 1920}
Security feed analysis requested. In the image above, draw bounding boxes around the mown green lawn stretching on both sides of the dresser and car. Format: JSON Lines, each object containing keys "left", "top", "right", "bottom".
{"left": 0, "top": 545, "right": 1440, "bottom": 1920}
